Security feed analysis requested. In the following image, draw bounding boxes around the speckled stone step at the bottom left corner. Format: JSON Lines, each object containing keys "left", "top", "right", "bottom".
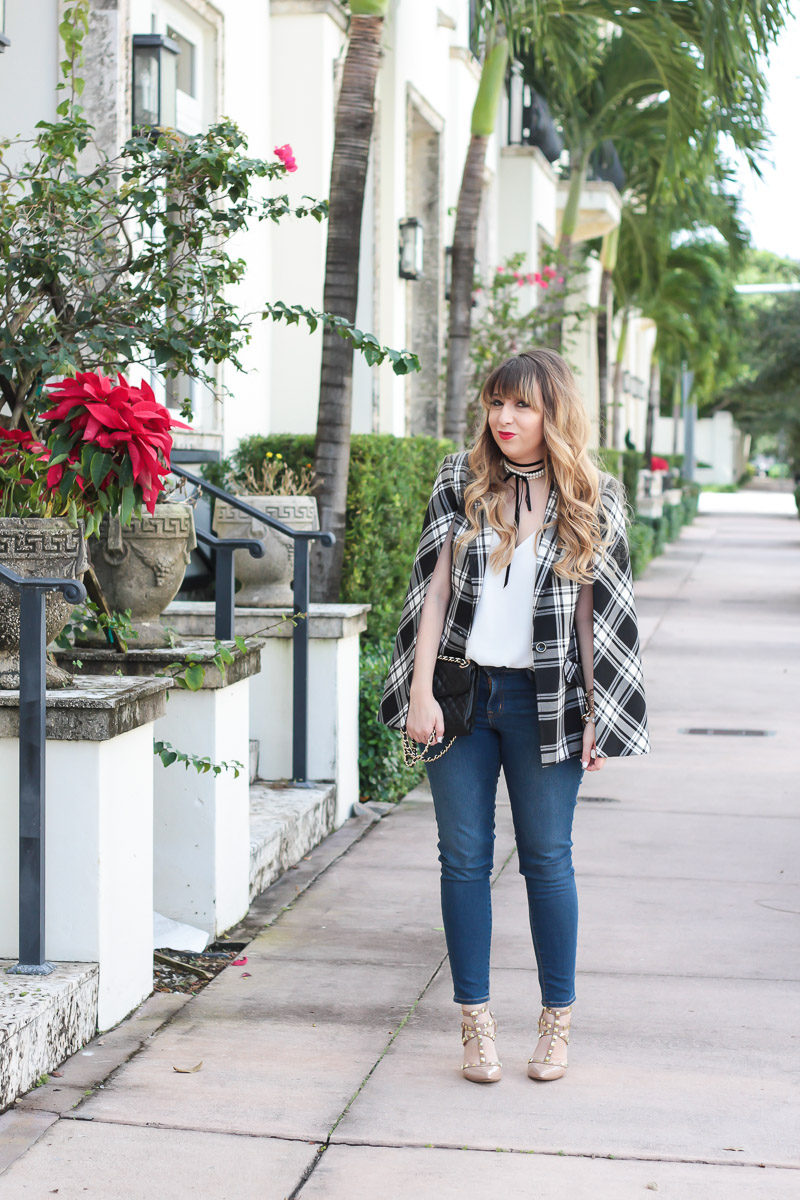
{"left": 0, "top": 959, "right": 100, "bottom": 1112}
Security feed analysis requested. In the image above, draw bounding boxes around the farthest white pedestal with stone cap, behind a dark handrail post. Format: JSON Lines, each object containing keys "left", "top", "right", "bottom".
{"left": 163, "top": 601, "right": 369, "bottom": 828}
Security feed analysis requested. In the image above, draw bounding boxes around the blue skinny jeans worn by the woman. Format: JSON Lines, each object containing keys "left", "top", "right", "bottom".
{"left": 426, "top": 667, "right": 584, "bottom": 1008}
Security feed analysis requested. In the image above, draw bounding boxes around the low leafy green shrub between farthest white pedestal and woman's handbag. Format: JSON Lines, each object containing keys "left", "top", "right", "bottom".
{"left": 359, "top": 637, "right": 425, "bottom": 800}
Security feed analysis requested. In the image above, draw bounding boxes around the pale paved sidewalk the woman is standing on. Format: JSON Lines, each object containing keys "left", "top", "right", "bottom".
{"left": 0, "top": 493, "right": 800, "bottom": 1200}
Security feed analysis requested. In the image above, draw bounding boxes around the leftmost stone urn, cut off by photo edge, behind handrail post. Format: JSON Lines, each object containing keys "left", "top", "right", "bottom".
{"left": 0, "top": 517, "right": 89, "bottom": 689}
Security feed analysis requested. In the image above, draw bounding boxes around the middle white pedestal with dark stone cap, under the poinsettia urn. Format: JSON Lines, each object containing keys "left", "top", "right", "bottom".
{"left": 59, "top": 638, "right": 263, "bottom": 938}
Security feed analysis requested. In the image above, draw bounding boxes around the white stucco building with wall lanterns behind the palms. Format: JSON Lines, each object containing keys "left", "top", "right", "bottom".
{"left": 0, "top": 0, "right": 654, "bottom": 451}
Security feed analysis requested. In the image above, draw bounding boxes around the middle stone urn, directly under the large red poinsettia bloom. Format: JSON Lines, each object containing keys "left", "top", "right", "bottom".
{"left": 88, "top": 503, "right": 197, "bottom": 649}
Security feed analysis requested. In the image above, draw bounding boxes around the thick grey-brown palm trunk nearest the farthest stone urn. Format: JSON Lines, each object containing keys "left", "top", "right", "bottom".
{"left": 312, "top": 11, "right": 389, "bottom": 602}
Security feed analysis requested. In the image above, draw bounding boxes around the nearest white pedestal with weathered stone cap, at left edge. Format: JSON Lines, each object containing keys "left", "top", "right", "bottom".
{"left": 0, "top": 677, "right": 169, "bottom": 1031}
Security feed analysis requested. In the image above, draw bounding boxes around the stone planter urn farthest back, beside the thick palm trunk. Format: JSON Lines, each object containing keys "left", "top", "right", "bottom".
{"left": 213, "top": 496, "right": 319, "bottom": 608}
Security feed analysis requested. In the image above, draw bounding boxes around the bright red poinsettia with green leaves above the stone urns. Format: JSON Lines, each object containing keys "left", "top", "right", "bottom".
{"left": 0, "top": 371, "right": 188, "bottom": 535}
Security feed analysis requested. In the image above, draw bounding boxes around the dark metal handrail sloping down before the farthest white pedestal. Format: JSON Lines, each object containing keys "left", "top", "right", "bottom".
{"left": 170, "top": 462, "right": 336, "bottom": 782}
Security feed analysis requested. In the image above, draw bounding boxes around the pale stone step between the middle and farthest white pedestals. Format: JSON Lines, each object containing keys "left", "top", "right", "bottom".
{"left": 249, "top": 779, "right": 336, "bottom": 900}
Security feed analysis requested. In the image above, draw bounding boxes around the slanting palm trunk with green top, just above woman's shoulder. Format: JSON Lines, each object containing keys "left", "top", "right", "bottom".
{"left": 444, "top": 37, "right": 509, "bottom": 445}
